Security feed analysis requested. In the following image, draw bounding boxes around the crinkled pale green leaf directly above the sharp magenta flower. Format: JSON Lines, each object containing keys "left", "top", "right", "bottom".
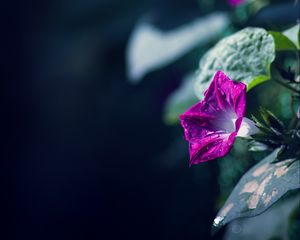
{"left": 194, "top": 27, "right": 275, "bottom": 99}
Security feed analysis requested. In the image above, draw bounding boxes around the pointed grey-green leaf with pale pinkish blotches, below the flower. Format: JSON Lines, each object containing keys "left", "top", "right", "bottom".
{"left": 213, "top": 149, "right": 300, "bottom": 231}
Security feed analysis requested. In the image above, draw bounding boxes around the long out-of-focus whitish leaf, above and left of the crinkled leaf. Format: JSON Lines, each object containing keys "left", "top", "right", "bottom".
{"left": 126, "top": 13, "right": 229, "bottom": 83}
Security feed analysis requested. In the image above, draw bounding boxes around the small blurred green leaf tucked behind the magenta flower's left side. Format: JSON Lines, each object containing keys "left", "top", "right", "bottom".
{"left": 164, "top": 74, "right": 198, "bottom": 124}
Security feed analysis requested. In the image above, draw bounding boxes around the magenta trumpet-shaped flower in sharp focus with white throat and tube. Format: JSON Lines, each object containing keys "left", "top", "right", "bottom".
{"left": 180, "top": 71, "right": 257, "bottom": 165}
